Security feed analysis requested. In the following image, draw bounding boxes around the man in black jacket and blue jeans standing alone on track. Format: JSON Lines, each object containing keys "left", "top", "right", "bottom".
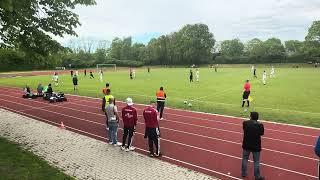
{"left": 241, "top": 112, "right": 264, "bottom": 180}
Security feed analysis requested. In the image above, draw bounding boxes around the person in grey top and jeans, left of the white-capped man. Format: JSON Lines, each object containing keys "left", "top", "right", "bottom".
{"left": 106, "top": 98, "right": 121, "bottom": 146}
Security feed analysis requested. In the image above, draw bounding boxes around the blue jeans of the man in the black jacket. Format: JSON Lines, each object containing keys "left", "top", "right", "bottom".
{"left": 241, "top": 149, "right": 260, "bottom": 178}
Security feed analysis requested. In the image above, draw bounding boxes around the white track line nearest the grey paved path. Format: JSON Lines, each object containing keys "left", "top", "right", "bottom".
{"left": 0, "top": 105, "right": 242, "bottom": 180}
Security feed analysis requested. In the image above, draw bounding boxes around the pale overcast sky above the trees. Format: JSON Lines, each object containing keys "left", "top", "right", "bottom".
{"left": 58, "top": 0, "right": 320, "bottom": 43}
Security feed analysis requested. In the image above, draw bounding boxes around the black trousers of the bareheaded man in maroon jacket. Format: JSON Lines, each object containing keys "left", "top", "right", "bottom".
{"left": 145, "top": 128, "right": 160, "bottom": 154}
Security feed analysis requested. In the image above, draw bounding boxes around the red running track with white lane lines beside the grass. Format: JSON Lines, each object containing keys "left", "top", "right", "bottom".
{"left": 0, "top": 87, "right": 320, "bottom": 180}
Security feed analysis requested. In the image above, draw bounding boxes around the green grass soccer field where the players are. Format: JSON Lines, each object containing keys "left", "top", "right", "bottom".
{"left": 0, "top": 68, "right": 320, "bottom": 127}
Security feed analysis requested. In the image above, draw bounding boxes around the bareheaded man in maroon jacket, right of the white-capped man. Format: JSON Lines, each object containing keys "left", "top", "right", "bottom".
{"left": 143, "top": 101, "right": 161, "bottom": 157}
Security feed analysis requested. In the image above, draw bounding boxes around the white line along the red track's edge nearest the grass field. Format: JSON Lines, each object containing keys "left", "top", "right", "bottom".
{"left": 0, "top": 86, "right": 320, "bottom": 131}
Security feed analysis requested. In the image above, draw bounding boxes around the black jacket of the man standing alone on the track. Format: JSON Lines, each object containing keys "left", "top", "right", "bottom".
{"left": 242, "top": 120, "right": 264, "bottom": 152}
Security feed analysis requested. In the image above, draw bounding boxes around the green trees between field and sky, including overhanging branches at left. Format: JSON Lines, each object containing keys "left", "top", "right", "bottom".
{"left": 0, "top": 0, "right": 320, "bottom": 70}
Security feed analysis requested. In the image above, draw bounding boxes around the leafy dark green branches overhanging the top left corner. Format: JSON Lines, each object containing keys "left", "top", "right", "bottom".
{"left": 0, "top": 0, "right": 95, "bottom": 56}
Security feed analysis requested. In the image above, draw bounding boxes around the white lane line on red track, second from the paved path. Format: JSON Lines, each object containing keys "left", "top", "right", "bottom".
{"left": 3, "top": 97, "right": 317, "bottom": 178}
